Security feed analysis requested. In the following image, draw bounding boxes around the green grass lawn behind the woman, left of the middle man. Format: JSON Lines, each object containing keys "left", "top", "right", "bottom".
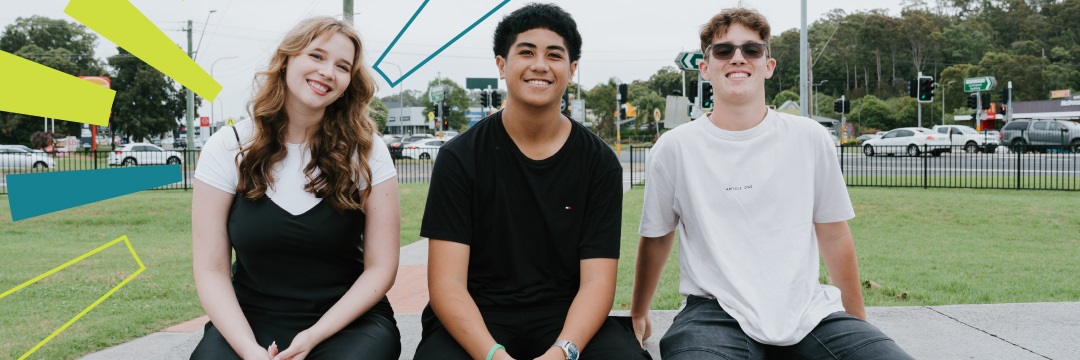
{"left": 0, "top": 184, "right": 428, "bottom": 359}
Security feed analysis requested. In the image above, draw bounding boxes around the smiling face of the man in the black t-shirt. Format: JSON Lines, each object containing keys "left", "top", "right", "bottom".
{"left": 495, "top": 28, "right": 578, "bottom": 109}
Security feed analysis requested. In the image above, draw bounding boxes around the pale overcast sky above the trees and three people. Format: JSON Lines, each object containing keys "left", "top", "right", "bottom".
{"left": 0, "top": 0, "right": 901, "bottom": 119}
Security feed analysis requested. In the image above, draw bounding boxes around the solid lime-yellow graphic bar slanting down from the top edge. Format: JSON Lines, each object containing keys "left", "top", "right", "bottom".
{"left": 64, "top": 0, "right": 221, "bottom": 102}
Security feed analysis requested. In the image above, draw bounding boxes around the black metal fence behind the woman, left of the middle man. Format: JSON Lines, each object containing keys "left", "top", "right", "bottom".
{"left": 0, "top": 149, "right": 434, "bottom": 195}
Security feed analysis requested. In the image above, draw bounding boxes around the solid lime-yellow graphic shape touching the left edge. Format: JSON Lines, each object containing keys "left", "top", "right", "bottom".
{"left": 0, "top": 51, "right": 117, "bottom": 126}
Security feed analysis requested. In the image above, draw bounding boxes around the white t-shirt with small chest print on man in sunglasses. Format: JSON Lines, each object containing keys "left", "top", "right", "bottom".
{"left": 638, "top": 109, "right": 855, "bottom": 346}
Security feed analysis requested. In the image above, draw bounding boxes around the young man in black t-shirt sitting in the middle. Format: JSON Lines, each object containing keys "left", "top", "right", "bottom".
{"left": 415, "top": 4, "right": 648, "bottom": 360}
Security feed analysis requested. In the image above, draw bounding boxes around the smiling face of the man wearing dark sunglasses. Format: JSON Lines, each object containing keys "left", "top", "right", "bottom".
{"left": 701, "top": 23, "right": 777, "bottom": 105}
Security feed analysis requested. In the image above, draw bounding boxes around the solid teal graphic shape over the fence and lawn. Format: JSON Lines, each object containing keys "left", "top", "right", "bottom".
{"left": 8, "top": 164, "right": 181, "bottom": 222}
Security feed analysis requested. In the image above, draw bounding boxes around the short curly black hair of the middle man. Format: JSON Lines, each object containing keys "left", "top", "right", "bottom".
{"left": 494, "top": 2, "right": 581, "bottom": 62}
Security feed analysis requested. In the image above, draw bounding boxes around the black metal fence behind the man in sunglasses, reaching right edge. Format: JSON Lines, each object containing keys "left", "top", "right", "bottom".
{"left": 629, "top": 145, "right": 1080, "bottom": 191}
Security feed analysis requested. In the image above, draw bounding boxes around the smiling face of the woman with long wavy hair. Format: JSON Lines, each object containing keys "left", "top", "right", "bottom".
{"left": 285, "top": 32, "right": 356, "bottom": 116}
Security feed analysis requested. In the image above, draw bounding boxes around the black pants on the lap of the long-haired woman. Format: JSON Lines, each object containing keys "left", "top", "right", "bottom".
{"left": 191, "top": 311, "right": 402, "bottom": 360}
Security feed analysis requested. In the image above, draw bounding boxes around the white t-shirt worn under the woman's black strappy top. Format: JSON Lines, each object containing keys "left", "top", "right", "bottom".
{"left": 194, "top": 120, "right": 397, "bottom": 215}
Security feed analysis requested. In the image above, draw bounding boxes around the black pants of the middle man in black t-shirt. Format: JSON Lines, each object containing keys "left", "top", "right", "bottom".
{"left": 413, "top": 305, "right": 652, "bottom": 360}
